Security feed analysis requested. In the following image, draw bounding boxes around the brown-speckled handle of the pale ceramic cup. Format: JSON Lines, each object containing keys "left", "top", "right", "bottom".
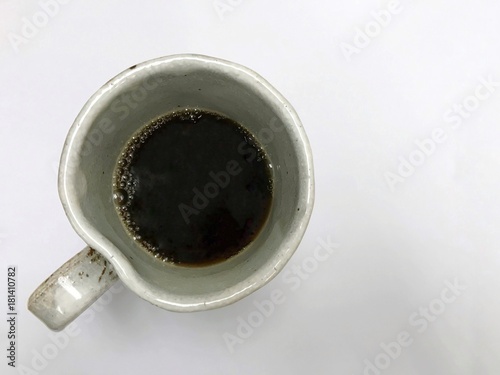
{"left": 28, "top": 247, "right": 118, "bottom": 331}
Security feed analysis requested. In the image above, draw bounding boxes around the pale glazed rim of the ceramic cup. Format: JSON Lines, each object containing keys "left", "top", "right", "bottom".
{"left": 58, "top": 54, "right": 314, "bottom": 312}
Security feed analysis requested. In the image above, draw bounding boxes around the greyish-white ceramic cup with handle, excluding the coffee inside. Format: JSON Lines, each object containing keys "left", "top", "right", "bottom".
{"left": 28, "top": 54, "right": 314, "bottom": 330}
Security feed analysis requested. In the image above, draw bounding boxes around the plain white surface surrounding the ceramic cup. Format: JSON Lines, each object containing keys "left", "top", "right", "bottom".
{"left": 0, "top": 0, "right": 500, "bottom": 375}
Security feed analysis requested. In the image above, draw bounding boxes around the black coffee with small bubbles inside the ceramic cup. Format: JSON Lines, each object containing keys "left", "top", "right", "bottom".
{"left": 113, "top": 109, "right": 272, "bottom": 265}
